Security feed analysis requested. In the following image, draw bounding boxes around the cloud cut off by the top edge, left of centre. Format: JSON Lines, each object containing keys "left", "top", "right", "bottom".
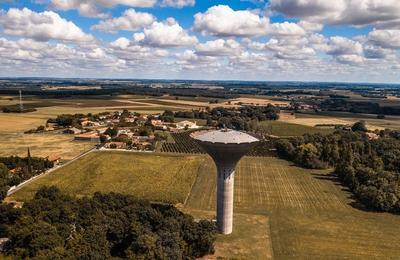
{"left": 50, "top": 0, "right": 157, "bottom": 18}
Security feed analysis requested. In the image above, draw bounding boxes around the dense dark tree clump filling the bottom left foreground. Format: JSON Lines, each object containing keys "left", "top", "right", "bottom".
{"left": 0, "top": 187, "right": 216, "bottom": 259}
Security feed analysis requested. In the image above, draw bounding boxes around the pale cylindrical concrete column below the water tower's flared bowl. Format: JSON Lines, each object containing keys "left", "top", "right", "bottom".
{"left": 217, "top": 164, "right": 236, "bottom": 234}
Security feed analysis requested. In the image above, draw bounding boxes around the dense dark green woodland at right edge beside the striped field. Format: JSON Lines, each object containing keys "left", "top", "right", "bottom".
{"left": 276, "top": 127, "right": 400, "bottom": 213}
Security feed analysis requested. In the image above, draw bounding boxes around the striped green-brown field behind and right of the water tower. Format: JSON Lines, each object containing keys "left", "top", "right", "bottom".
{"left": 186, "top": 157, "right": 400, "bottom": 259}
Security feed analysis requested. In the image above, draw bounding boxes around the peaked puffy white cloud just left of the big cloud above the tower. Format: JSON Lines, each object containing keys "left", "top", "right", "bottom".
{"left": 133, "top": 18, "right": 197, "bottom": 48}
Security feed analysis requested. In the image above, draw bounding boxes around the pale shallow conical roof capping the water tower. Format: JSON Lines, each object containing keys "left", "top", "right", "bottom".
{"left": 192, "top": 129, "right": 259, "bottom": 144}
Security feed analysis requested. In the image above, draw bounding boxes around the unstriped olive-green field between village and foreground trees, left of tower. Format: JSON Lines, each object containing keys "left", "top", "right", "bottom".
{"left": 10, "top": 152, "right": 202, "bottom": 203}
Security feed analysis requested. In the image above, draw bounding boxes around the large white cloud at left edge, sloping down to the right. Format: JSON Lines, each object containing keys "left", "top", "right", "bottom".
{"left": 0, "top": 8, "right": 94, "bottom": 42}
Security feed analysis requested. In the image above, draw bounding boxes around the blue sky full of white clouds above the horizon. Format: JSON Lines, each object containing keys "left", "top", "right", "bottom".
{"left": 0, "top": 0, "right": 400, "bottom": 83}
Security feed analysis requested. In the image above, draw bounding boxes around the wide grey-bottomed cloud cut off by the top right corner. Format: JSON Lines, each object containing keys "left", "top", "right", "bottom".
{"left": 270, "top": 0, "right": 400, "bottom": 27}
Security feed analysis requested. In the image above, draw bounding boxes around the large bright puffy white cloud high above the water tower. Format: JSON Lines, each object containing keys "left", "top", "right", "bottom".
{"left": 194, "top": 5, "right": 269, "bottom": 37}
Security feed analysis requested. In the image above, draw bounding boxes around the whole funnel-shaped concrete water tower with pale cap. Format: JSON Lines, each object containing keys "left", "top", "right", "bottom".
{"left": 191, "top": 129, "right": 259, "bottom": 234}
